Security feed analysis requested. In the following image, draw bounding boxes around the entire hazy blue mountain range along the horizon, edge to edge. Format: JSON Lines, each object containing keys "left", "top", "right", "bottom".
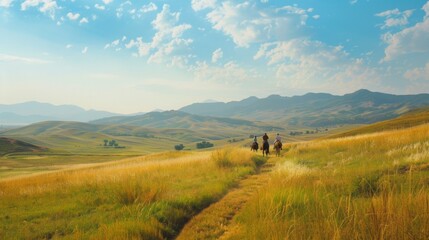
{"left": 0, "top": 89, "right": 429, "bottom": 129}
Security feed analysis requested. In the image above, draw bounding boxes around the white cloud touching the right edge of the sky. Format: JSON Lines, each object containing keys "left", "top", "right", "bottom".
{"left": 382, "top": 3, "right": 429, "bottom": 61}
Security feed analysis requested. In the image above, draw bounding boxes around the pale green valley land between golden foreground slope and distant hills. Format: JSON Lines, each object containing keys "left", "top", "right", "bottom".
{"left": 0, "top": 119, "right": 350, "bottom": 179}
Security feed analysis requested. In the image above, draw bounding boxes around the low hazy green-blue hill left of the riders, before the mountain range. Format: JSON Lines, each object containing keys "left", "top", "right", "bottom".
{"left": 90, "top": 111, "right": 278, "bottom": 130}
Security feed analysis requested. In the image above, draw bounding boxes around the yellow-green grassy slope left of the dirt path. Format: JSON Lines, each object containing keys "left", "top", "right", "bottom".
{"left": 0, "top": 149, "right": 263, "bottom": 239}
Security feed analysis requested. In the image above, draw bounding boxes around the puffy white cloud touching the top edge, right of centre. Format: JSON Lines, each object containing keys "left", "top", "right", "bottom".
{"left": 207, "top": 1, "right": 308, "bottom": 47}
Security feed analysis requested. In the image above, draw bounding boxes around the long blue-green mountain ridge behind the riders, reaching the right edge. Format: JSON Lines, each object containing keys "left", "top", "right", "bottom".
{"left": 179, "top": 89, "right": 429, "bottom": 127}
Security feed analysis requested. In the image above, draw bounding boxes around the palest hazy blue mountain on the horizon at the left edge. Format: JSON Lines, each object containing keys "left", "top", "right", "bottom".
{"left": 0, "top": 102, "right": 119, "bottom": 125}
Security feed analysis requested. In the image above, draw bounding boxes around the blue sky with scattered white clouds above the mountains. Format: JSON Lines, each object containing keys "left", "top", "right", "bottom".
{"left": 0, "top": 0, "right": 429, "bottom": 113}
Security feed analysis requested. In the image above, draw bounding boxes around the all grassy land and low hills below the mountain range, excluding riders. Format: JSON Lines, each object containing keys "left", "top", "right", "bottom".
{"left": 0, "top": 91, "right": 429, "bottom": 239}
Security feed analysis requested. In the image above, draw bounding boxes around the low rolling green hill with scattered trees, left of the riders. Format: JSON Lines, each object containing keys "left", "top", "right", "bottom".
{"left": 0, "top": 119, "right": 265, "bottom": 155}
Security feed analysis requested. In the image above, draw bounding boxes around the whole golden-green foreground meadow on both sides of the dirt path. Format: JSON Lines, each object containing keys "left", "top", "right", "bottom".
{"left": 0, "top": 111, "right": 429, "bottom": 239}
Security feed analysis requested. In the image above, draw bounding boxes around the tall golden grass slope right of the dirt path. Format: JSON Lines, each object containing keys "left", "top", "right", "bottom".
{"left": 227, "top": 124, "right": 429, "bottom": 239}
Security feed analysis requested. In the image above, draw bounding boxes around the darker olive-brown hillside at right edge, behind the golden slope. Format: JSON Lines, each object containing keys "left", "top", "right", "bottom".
{"left": 329, "top": 108, "right": 429, "bottom": 138}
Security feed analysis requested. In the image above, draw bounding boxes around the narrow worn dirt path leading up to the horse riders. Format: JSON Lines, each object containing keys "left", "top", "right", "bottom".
{"left": 177, "top": 158, "right": 274, "bottom": 240}
